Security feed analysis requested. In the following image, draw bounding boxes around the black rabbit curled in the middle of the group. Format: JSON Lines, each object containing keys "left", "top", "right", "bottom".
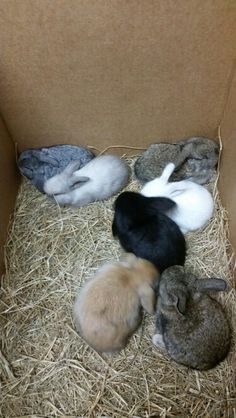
{"left": 112, "top": 192, "right": 186, "bottom": 272}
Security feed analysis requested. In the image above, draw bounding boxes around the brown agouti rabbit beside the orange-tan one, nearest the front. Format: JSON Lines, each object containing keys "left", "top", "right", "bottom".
{"left": 153, "top": 266, "right": 231, "bottom": 370}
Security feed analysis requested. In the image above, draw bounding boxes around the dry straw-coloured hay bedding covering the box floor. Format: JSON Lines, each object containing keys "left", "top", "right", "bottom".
{"left": 0, "top": 158, "right": 236, "bottom": 418}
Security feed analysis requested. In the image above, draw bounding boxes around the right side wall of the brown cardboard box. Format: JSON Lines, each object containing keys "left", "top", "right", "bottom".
{"left": 220, "top": 67, "right": 236, "bottom": 258}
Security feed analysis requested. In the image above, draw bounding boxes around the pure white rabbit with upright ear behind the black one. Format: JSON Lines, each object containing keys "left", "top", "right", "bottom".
{"left": 141, "top": 163, "right": 214, "bottom": 234}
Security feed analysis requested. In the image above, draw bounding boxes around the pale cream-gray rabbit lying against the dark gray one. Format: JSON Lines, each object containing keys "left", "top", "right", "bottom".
{"left": 44, "top": 155, "right": 129, "bottom": 207}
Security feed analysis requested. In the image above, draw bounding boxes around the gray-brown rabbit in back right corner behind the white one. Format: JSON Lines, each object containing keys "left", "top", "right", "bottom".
{"left": 134, "top": 137, "right": 219, "bottom": 184}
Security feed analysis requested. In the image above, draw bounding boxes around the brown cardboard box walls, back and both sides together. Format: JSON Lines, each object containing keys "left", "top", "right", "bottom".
{"left": 0, "top": 0, "right": 236, "bottom": 278}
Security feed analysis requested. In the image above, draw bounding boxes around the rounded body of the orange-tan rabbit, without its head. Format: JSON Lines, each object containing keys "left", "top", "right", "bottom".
{"left": 74, "top": 266, "right": 144, "bottom": 352}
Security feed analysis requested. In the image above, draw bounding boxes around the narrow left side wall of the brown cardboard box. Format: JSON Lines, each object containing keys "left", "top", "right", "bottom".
{"left": 0, "top": 118, "right": 19, "bottom": 276}
